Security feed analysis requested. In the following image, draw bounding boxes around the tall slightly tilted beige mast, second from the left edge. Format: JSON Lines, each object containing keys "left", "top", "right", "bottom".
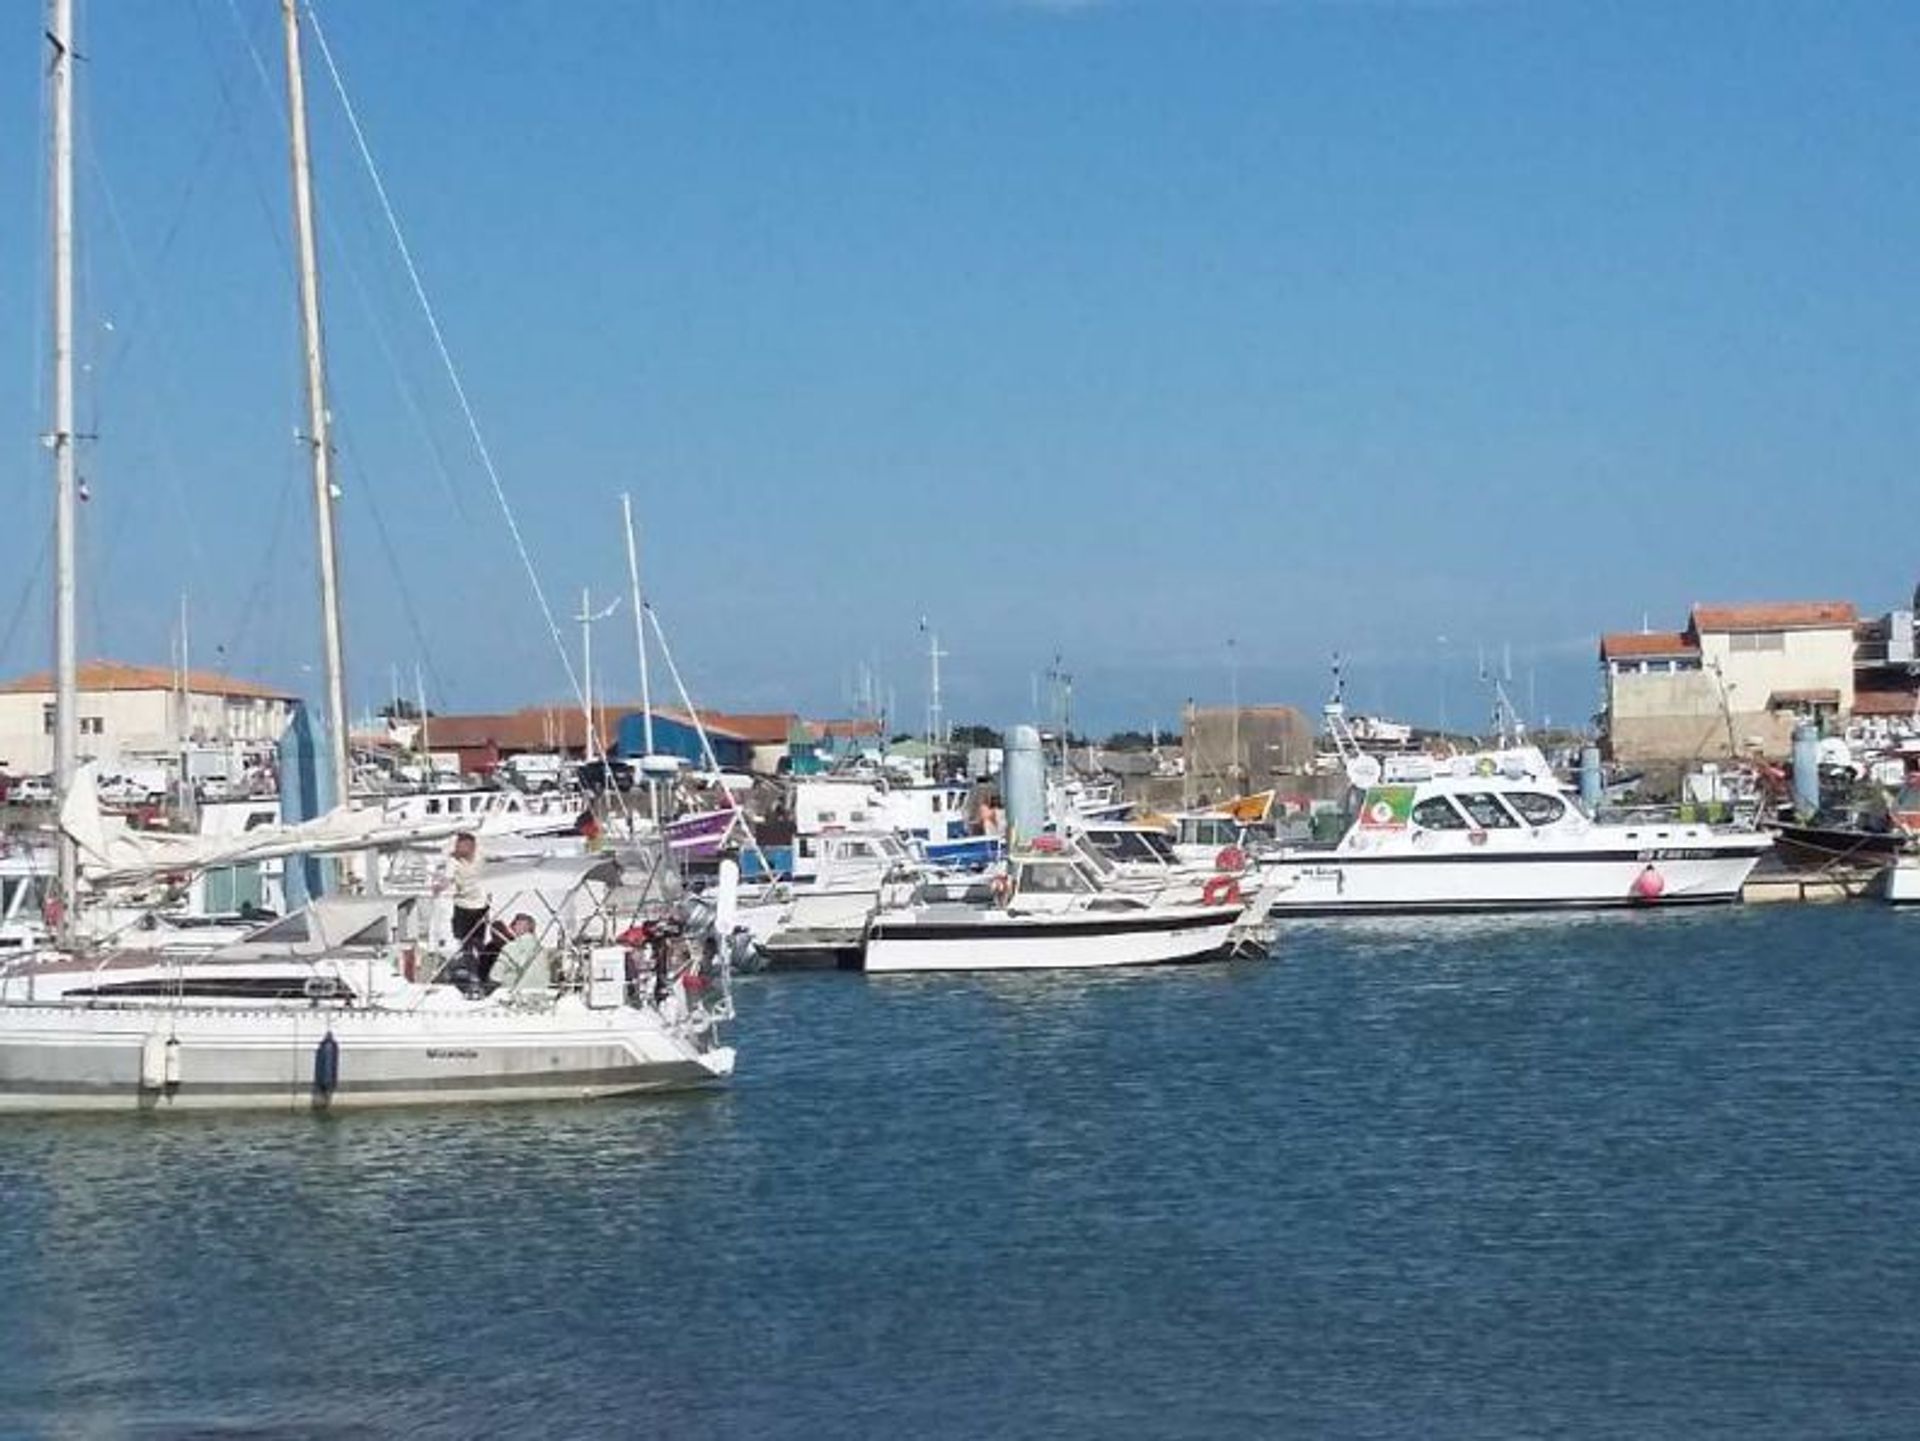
{"left": 280, "top": 0, "right": 353, "bottom": 806}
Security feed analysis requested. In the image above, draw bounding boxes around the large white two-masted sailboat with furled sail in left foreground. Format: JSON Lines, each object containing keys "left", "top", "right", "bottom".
{"left": 0, "top": 0, "right": 733, "bottom": 1111}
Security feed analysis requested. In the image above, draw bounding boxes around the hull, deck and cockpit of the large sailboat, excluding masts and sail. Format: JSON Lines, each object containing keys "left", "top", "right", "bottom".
{"left": 0, "top": 862, "right": 733, "bottom": 1111}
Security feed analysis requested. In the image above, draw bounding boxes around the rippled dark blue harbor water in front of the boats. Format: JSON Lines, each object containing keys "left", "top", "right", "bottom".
{"left": 0, "top": 906, "right": 1920, "bottom": 1437}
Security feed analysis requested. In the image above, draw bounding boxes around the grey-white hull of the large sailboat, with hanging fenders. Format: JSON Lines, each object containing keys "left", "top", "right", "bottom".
{"left": 0, "top": 998, "right": 733, "bottom": 1111}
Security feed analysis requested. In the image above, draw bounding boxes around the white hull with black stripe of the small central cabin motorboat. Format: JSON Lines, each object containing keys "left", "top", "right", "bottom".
{"left": 864, "top": 906, "right": 1240, "bottom": 973}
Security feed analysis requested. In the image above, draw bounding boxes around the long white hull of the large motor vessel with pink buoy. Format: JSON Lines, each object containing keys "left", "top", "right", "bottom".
{"left": 1261, "top": 844, "right": 1764, "bottom": 919}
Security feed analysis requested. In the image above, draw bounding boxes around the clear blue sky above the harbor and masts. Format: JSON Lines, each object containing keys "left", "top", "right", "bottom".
{"left": 0, "top": 0, "right": 1920, "bottom": 727}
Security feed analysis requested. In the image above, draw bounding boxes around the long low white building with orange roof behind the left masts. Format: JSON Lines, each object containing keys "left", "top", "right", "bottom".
{"left": 0, "top": 660, "right": 294, "bottom": 775}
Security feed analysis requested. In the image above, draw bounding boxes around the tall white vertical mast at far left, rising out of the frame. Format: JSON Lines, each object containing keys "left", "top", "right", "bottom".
{"left": 46, "top": 0, "right": 81, "bottom": 913}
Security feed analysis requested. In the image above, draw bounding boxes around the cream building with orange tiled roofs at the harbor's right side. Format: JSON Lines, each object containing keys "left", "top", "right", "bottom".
{"left": 1599, "top": 601, "right": 1859, "bottom": 762}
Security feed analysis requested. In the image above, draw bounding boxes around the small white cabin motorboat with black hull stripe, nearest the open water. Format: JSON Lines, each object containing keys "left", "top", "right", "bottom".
{"left": 864, "top": 850, "right": 1242, "bottom": 973}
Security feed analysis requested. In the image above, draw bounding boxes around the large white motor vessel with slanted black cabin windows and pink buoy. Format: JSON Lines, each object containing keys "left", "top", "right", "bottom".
{"left": 1260, "top": 746, "right": 1772, "bottom": 917}
